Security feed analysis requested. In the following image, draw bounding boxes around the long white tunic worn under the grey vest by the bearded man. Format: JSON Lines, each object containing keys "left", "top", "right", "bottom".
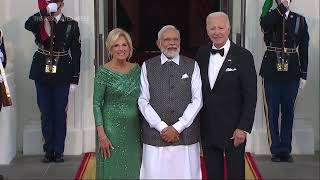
{"left": 138, "top": 54, "right": 202, "bottom": 179}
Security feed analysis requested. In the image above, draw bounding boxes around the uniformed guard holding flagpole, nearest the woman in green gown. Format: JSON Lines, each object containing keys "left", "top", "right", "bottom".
{"left": 25, "top": 0, "right": 81, "bottom": 162}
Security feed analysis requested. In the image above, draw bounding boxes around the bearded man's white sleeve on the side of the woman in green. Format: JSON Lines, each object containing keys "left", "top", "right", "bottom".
{"left": 138, "top": 63, "right": 168, "bottom": 132}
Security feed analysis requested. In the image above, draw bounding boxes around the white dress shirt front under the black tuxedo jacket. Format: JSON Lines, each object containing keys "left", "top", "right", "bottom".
{"left": 208, "top": 39, "right": 230, "bottom": 89}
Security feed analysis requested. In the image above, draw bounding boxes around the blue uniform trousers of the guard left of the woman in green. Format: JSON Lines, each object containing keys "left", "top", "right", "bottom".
{"left": 35, "top": 81, "right": 70, "bottom": 154}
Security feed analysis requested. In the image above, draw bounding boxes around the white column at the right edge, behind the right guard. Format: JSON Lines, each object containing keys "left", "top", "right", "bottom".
{"left": 291, "top": 0, "right": 320, "bottom": 153}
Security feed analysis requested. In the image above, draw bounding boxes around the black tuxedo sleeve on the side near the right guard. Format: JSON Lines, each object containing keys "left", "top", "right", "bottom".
{"left": 237, "top": 50, "right": 257, "bottom": 133}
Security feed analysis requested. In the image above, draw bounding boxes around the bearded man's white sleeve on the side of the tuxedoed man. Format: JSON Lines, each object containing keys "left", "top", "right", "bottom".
{"left": 173, "top": 62, "right": 202, "bottom": 133}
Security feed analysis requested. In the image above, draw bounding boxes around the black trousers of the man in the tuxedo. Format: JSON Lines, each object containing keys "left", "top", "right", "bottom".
{"left": 203, "top": 140, "right": 245, "bottom": 180}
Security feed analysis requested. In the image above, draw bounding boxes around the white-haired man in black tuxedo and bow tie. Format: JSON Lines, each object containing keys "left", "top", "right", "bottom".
{"left": 196, "top": 12, "right": 257, "bottom": 179}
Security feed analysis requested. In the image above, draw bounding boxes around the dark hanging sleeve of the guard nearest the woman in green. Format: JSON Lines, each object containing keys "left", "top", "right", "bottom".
{"left": 70, "top": 22, "right": 81, "bottom": 84}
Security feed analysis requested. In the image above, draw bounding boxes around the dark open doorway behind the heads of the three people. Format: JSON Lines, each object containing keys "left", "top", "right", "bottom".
{"left": 95, "top": 0, "right": 245, "bottom": 64}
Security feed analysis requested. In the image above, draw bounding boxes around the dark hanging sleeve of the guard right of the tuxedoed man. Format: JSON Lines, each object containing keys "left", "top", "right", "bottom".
{"left": 298, "top": 17, "right": 309, "bottom": 79}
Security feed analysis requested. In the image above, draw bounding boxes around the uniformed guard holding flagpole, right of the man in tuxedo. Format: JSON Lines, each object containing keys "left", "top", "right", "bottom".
{"left": 260, "top": 0, "right": 309, "bottom": 162}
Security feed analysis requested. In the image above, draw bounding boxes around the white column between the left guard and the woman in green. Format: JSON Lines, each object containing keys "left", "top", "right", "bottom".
{"left": 60, "top": 0, "right": 95, "bottom": 154}
